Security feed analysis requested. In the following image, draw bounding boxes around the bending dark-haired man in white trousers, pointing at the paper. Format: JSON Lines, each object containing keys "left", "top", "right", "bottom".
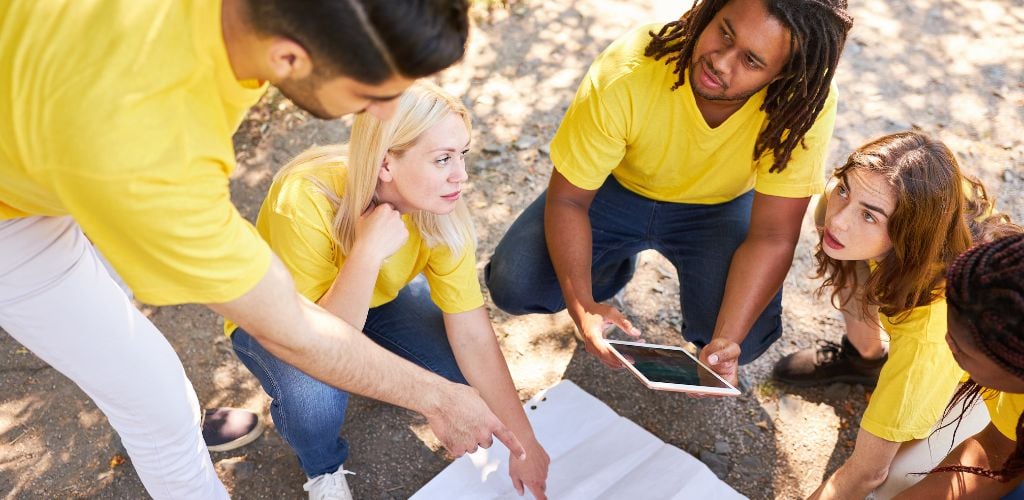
{"left": 0, "top": 0, "right": 522, "bottom": 499}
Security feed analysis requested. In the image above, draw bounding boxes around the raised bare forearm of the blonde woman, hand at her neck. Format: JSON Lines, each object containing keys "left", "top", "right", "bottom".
{"left": 316, "top": 247, "right": 381, "bottom": 330}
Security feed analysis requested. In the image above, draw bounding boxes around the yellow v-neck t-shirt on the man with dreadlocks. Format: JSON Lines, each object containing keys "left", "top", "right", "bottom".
{"left": 551, "top": 25, "right": 838, "bottom": 204}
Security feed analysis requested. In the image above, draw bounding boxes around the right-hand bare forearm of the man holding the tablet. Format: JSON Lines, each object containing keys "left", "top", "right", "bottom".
{"left": 714, "top": 238, "right": 796, "bottom": 344}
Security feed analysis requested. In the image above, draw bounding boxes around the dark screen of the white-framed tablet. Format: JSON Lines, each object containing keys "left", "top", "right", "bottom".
{"left": 614, "top": 342, "right": 729, "bottom": 388}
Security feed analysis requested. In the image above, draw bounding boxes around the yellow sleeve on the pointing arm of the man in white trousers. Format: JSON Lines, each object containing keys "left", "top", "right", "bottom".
{"left": 49, "top": 159, "right": 270, "bottom": 305}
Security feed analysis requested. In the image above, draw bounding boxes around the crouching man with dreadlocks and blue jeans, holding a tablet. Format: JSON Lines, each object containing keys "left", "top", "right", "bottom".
{"left": 486, "top": 0, "right": 852, "bottom": 384}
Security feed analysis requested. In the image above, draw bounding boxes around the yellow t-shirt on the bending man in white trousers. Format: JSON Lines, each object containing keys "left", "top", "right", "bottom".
{"left": 0, "top": 0, "right": 270, "bottom": 304}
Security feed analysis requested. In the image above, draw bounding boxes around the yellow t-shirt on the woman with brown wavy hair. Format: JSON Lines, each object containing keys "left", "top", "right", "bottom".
{"left": 860, "top": 299, "right": 964, "bottom": 443}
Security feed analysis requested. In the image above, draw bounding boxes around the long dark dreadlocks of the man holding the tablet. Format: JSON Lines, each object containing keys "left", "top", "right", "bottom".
{"left": 644, "top": 0, "right": 853, "bottom": 172}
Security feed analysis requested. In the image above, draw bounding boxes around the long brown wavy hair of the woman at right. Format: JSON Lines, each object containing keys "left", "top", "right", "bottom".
{"left": 814, "top": 131, "right": 1019, "bottom": 321}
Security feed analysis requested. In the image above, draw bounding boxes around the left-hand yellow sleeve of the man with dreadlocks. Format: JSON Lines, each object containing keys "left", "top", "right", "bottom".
{"left": 551, "top": 58, "right": 630, "bottom": 190}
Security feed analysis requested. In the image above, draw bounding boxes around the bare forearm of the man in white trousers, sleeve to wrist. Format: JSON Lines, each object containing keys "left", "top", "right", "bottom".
{"left": 209, "top": 258, "right": 449, "bottom": 416}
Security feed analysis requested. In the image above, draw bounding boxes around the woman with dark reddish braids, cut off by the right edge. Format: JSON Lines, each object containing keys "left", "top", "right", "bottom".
{"left": 899, "top": 234, "right": 1024, "bottom": 499}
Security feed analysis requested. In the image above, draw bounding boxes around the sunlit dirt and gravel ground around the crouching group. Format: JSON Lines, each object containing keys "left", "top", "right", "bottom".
{"left": 0, "top": 0, "right": 1024, "bottom": 499}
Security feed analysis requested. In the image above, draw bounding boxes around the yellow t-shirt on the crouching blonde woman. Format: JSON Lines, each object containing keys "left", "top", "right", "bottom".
{"left": 224, "top": 164, "right": 483, "bottom": 335}
